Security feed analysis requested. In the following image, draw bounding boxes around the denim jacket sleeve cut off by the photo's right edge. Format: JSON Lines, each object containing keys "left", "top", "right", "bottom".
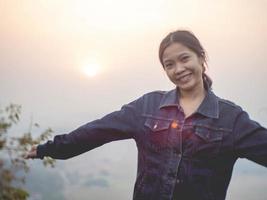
{"left": 234, "top": 110, "right": 267, "bottom": 167}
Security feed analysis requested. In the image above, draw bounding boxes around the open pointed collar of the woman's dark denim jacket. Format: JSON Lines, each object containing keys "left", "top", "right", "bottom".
{"left": 159, "top": 88, "right": 219, "bottom": 118}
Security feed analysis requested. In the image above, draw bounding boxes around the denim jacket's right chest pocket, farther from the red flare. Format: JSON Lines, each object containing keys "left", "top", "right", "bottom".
{"left": 192, "top": 126, "right": 225, "bottom": 157}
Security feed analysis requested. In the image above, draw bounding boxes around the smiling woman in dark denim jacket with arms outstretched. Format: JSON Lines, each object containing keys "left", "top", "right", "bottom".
{"left": 26, "top": 30, "right": 267, "bottom": 200}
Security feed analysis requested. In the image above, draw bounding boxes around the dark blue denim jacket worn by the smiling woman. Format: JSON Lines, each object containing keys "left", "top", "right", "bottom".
{"left": 37, "top": 89, "right": 267, "bottom": 200}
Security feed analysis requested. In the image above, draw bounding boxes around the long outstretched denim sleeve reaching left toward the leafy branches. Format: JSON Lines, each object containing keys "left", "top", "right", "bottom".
{"left": 37, "top": 97, "right": 142, "bottom": 159}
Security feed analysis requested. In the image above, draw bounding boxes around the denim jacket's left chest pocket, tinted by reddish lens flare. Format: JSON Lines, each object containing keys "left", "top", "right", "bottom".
{"left": 144, "top": 118, "right": 171, "bottom": 150}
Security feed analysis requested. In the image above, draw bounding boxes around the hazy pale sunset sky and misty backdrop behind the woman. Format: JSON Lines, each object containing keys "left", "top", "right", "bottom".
{"left": 0, "top": 0, "right": 267, "bottom": 200}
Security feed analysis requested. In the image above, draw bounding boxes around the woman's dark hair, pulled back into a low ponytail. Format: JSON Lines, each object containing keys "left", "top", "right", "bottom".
{"left": 159, "top": 30, "right": 212, "bottom": 89}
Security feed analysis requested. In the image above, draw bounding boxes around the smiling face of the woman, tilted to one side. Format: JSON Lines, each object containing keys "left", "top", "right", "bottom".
{"left": 162, "top": 42, "right": 204, "bottom": 92}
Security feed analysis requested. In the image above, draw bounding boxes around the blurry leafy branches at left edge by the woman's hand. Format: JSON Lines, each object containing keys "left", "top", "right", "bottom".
{"left": 0, "top": 104, "right": 55, "bottom": 200}
